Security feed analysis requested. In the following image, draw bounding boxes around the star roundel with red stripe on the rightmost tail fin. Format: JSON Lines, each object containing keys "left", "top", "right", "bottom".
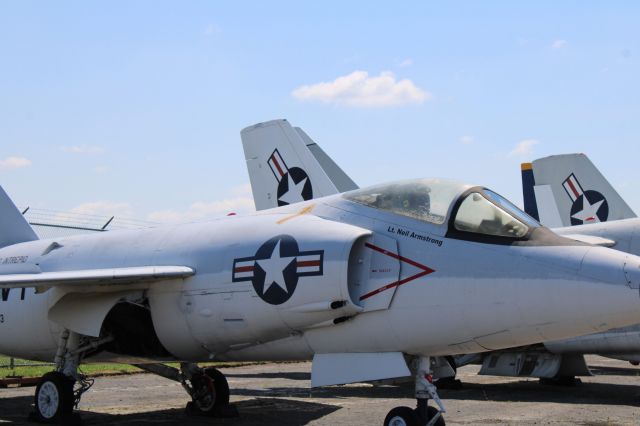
{"left": 562, "top": 173, "right": 609, "bottom": 226}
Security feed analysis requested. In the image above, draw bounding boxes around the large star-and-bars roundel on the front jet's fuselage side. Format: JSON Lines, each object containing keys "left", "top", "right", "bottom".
{"left": 232, "top": 234, "right": 324, "bottom": 305}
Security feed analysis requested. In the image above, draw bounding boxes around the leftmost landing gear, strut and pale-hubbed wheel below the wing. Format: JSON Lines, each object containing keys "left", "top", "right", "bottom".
{"left": 31, "top": 330, "right": 99, "bottom": 424}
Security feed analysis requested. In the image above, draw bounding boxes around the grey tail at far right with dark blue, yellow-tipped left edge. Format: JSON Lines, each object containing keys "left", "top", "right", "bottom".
{"left": 522, "top": 154, "right": 636, "bottom": 228}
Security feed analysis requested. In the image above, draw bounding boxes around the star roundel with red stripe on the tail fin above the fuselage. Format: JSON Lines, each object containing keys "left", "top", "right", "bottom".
{"left": 267, "top": 149, "right": 313, "bottom": 206}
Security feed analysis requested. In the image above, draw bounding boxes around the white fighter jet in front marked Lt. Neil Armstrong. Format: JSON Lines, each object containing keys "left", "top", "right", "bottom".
{"left": 0, "top": 131, "right": 640, "bottom": 425}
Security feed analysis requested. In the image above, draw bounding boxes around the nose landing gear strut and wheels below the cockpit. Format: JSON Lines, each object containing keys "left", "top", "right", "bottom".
{"left": 384, "top": 357, "right": 446, "bottom": 426}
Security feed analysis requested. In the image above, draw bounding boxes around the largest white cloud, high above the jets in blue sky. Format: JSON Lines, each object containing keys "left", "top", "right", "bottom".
{"left": 292, "top": 71, "right": 432, "bottom": 107}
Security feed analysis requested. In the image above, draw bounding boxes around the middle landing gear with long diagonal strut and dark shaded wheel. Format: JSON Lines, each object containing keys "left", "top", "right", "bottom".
{"left": 136, "top": 362, "right": 238, "bottom": 417}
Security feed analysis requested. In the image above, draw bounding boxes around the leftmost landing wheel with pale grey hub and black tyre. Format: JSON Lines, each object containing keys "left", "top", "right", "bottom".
{"left": 35, "top": 372, "right": 75, "bottom": 423}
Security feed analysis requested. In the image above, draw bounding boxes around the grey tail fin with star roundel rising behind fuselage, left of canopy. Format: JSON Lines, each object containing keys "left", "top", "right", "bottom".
{"left": 240, "top": 120, "right": 358, "bottom": 210}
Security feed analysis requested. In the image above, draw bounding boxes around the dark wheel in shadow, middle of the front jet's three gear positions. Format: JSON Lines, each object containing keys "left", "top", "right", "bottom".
{"left": 187, "top": 368, "right": 231, "bottom": 417}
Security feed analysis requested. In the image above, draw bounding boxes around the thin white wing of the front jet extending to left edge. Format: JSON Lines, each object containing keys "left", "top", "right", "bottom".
{"left": 0, "top": 265, "right": 195, "bottom": 288}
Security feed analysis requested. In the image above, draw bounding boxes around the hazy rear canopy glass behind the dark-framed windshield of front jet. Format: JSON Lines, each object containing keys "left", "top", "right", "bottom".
{"left": 344, "top": 179, "right": 471, "bottom": 225}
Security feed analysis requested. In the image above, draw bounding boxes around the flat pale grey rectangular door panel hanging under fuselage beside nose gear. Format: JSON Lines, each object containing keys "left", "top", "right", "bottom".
{"left": 311, "top": 352, "right": 411, "bottom": 387}
